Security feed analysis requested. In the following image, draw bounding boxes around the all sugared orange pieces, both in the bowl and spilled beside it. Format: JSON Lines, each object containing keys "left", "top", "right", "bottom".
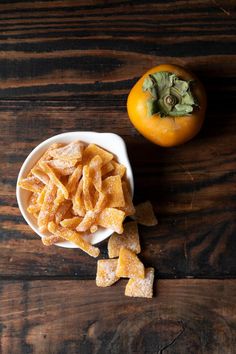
{"left": 19, "top": 141, "right": 157, "bottom": 298}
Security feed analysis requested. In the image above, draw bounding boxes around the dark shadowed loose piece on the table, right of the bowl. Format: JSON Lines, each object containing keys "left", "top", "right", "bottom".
{"left": 132, "top": 201, "right": 158, "bottom": 226}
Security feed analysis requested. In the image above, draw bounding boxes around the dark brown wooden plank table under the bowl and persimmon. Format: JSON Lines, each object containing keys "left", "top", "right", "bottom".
{"left": 0, "top": 0, "right": 236, "bottom": 354}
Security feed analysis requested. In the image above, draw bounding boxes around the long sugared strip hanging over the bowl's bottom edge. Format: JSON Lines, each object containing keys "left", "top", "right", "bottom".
{"left": 48, "top": 222, "right": 100, "bottom": 257}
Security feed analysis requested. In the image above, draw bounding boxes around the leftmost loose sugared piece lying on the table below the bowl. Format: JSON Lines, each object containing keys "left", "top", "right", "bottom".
{"left": 96, "top": 259, "right": 119, "bottom": 287}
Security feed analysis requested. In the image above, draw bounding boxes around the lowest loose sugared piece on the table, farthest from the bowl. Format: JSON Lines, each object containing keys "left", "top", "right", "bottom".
{"left": 125, "top": 268, "right": 154, "bottom": 298}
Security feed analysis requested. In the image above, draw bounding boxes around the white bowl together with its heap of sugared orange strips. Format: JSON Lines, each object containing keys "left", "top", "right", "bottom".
{"left": 16, "top": 132, "right": 135, "bottom": 250}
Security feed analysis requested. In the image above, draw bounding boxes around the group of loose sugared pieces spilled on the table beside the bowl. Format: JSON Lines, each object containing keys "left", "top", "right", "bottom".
{"left": 96, "top": 202, "right": 157, "bottom": 298}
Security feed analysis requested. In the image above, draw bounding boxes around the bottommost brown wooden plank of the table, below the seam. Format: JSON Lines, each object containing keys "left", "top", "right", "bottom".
{"left": 0, "top": 280, "right": 236, "bottom": 354}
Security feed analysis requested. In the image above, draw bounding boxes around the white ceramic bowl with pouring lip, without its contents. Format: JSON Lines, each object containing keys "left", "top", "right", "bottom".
{"left": 16, "top": 132, "right": 134, "bottom": 248}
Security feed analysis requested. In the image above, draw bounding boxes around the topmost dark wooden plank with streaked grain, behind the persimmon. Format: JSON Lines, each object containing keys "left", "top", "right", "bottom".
{"left": 0, "top": 0, "right": 233, "bottom": 98}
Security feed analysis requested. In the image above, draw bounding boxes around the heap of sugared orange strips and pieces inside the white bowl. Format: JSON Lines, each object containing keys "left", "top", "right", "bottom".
{"left": 18, "top": 141, "right": 135, "bottom": 253}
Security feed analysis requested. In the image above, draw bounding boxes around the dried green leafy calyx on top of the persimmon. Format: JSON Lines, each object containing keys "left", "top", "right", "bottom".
{"left": 142, "top": 71, "right": 199, "bottom": 117}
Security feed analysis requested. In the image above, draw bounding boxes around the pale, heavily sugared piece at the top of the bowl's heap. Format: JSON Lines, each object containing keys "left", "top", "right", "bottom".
{"left": 50, "top": 141, "right": 84, "bottom": 161}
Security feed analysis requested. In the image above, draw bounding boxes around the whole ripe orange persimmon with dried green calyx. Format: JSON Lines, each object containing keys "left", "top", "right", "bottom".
{"left": 127, "top": 64, "right": 207, "bottom": 147}
